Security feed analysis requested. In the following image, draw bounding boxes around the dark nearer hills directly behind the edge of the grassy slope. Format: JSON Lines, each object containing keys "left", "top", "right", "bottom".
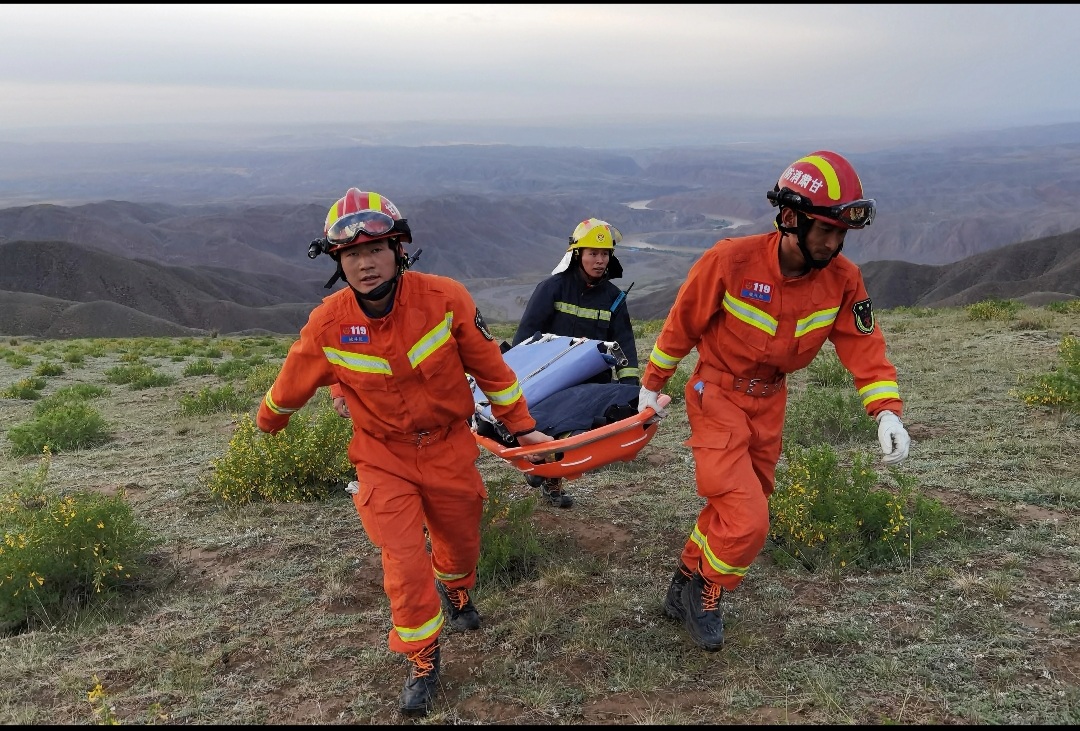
{"left": 0, "top": 230, "right": 1080, "bottom": 338}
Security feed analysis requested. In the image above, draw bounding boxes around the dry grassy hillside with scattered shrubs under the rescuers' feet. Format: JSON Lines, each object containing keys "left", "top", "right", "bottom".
{"left": 0, "top": 300, "right": 1080, "bottom": 725}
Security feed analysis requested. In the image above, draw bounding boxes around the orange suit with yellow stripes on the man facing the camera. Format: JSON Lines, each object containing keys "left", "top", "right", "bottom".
{"left": 257, "top": 272, "right": 536, "bottom": 652}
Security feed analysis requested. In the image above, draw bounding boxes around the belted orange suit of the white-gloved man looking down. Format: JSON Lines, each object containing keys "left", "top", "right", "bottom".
{"left": 642, "top": 231, "right": 903, "bottom": 591}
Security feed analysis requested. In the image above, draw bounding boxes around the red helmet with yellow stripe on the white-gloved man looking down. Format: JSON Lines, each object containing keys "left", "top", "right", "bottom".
{"left": 767, "top": 150, "right": 875, "bottom": 229}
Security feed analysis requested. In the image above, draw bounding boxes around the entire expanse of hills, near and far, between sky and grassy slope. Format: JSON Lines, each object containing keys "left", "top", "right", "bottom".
{"left": 6, "top": 124, "right": 1080, "bottom": 337}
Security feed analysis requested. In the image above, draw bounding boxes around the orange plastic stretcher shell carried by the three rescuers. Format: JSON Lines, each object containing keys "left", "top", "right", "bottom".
{"left": 473, "top": 393, "right": 671, "bottom": 479}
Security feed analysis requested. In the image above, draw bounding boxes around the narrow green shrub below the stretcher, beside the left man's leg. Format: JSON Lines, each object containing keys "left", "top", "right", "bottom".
{"left": 476, "top": 478, "right": 544, "bottom": 587}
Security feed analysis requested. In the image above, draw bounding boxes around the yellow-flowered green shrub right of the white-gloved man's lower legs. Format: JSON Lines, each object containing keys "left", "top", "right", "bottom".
{"left": 769, "top": 445, "right": 960, "bottom": 571}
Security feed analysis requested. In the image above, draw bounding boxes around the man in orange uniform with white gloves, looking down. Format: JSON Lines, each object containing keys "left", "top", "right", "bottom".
{"left": 638, "top": 150, "right": 909, "bottom": 650}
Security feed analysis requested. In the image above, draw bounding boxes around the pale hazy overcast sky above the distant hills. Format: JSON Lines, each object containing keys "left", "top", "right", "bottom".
{"left": 0, "top": 3, "right": 1080, "bottom": 133}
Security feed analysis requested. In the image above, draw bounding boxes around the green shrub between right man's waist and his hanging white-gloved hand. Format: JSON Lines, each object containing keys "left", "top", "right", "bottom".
{"left": 784, "top": 385, "right": 877, "bottom": 447}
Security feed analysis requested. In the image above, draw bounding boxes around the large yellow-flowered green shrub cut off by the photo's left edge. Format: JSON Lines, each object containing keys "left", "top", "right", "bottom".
{"left": 0, "top": 451, "right": 159, "bottom": 625}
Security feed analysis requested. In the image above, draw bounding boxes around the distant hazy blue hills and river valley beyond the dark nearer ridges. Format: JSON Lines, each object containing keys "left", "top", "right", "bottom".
{"left": 6, "top": 123, "right": 1080, "bottom": 279}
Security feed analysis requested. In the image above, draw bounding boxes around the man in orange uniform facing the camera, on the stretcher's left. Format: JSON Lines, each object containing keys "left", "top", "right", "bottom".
{"left": 257, "top": 188, "right": 552, "bottom": 715}
